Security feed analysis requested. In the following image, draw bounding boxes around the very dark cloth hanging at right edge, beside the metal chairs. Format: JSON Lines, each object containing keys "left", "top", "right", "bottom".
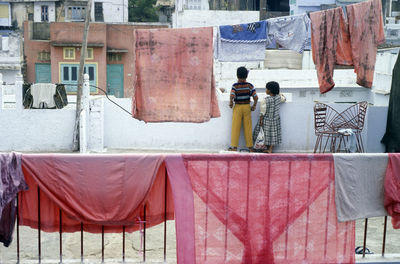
{"left": 381, "top": 53, "right": 400, "bottom": 152}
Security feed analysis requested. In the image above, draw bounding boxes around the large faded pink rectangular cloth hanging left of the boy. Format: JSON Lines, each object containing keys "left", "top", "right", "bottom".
{"left": 132, "top": 27, "right": 220, "bottom": 123}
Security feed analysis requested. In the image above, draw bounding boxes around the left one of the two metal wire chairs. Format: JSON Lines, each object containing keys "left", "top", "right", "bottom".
{"left": 314, "top": 102, "right": 341, "bottom": 153}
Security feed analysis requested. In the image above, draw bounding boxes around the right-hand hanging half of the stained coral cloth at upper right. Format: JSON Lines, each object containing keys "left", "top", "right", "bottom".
{"left": 346, "top": 0, "right": 385, "bottom": 88}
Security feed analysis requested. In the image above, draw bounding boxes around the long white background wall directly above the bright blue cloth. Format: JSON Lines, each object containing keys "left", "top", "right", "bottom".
{"left": 172, "top": 10, "right": 260, "bottom": 28}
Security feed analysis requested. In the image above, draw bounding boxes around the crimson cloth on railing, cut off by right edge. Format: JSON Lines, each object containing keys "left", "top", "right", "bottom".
{"left": 384, "top": 153, "right": 400, "bottom": 229}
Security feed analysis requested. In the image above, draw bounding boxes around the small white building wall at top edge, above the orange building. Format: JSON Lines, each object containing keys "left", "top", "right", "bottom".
{"left": 91, "top": 0, "right": 128, "bottom": 23}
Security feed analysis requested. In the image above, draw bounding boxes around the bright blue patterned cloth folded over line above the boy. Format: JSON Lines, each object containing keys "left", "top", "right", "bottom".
{"left": 219, "top": 21, "right": 267, "bottom": 43}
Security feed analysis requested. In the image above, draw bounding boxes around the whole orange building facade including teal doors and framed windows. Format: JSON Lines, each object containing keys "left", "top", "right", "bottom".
{"left": 24, "top": 21, "right": 168, "bottom": 97}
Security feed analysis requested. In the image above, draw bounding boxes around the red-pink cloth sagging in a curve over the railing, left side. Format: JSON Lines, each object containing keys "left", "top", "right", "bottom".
{"left": 19, "top": 154, "right": 174, "bottom": 233}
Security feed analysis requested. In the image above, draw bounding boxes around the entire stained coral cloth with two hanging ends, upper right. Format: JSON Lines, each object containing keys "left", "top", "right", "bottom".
{"left": 310, "top": 0, "right": 385, "bottom": 93}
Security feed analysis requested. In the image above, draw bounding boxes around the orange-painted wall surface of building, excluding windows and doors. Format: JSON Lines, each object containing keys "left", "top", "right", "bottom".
{"left": 24, "top": 22, "right": 167, "bottom": 97}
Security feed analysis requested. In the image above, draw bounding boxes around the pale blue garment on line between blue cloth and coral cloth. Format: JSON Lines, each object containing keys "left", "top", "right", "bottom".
{"left": 267, "top": 14, "right": 311, "bottom": 53}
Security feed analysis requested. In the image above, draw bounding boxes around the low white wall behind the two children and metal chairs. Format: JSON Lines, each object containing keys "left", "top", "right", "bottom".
{"left": 104, "top": 95, "right": 387, "bottom": 152}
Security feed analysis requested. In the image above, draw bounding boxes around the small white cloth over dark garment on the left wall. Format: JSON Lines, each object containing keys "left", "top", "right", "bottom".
{"left": 31, "top": 83, "right": 56, "bottom": 108}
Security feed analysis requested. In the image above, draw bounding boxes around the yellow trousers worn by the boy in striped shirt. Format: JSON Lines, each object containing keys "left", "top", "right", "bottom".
{"left": 231, "top": 104, "right": 253, "bottom": 148}
